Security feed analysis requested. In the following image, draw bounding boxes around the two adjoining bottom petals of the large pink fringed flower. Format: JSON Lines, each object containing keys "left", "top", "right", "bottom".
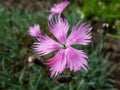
{"left": 46, "top": 47, "right": 88, "bottom": 77}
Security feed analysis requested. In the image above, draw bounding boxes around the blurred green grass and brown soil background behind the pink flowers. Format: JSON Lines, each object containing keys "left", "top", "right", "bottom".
{"left": 0, "top": 0, "right": 120, "bottom": 90}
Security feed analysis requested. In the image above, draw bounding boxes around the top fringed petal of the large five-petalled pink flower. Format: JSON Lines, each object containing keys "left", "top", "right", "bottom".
{"left": 49, "top": 17, "right": 69, "bottom": 44}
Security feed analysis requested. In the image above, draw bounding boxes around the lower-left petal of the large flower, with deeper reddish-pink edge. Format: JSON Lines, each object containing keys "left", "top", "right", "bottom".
{"left": 47, "top": 49, "right": 66, "bottom": 77}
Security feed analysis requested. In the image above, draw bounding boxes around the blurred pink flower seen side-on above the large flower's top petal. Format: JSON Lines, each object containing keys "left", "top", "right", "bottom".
{"left": 48, "top": 0, "right": 70, "bottom": 20}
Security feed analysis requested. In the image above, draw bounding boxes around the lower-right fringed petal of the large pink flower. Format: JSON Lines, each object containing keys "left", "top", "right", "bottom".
{"left": 65, "top": 47, "right": 88, "bottom": 72}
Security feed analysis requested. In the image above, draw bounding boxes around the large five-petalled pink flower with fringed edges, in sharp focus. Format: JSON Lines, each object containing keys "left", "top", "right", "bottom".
{"left": 33, "top": 17, "right": 92, "bottom": 77}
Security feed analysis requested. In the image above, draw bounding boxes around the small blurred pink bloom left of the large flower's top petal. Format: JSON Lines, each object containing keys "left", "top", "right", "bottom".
{"left": 28, "top": 25, "right": 41, "bottom": 37}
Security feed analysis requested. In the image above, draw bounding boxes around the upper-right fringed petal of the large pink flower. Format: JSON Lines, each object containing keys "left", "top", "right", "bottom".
{"left": 67, "top": 23, "right": 92, "bottom": 45}
